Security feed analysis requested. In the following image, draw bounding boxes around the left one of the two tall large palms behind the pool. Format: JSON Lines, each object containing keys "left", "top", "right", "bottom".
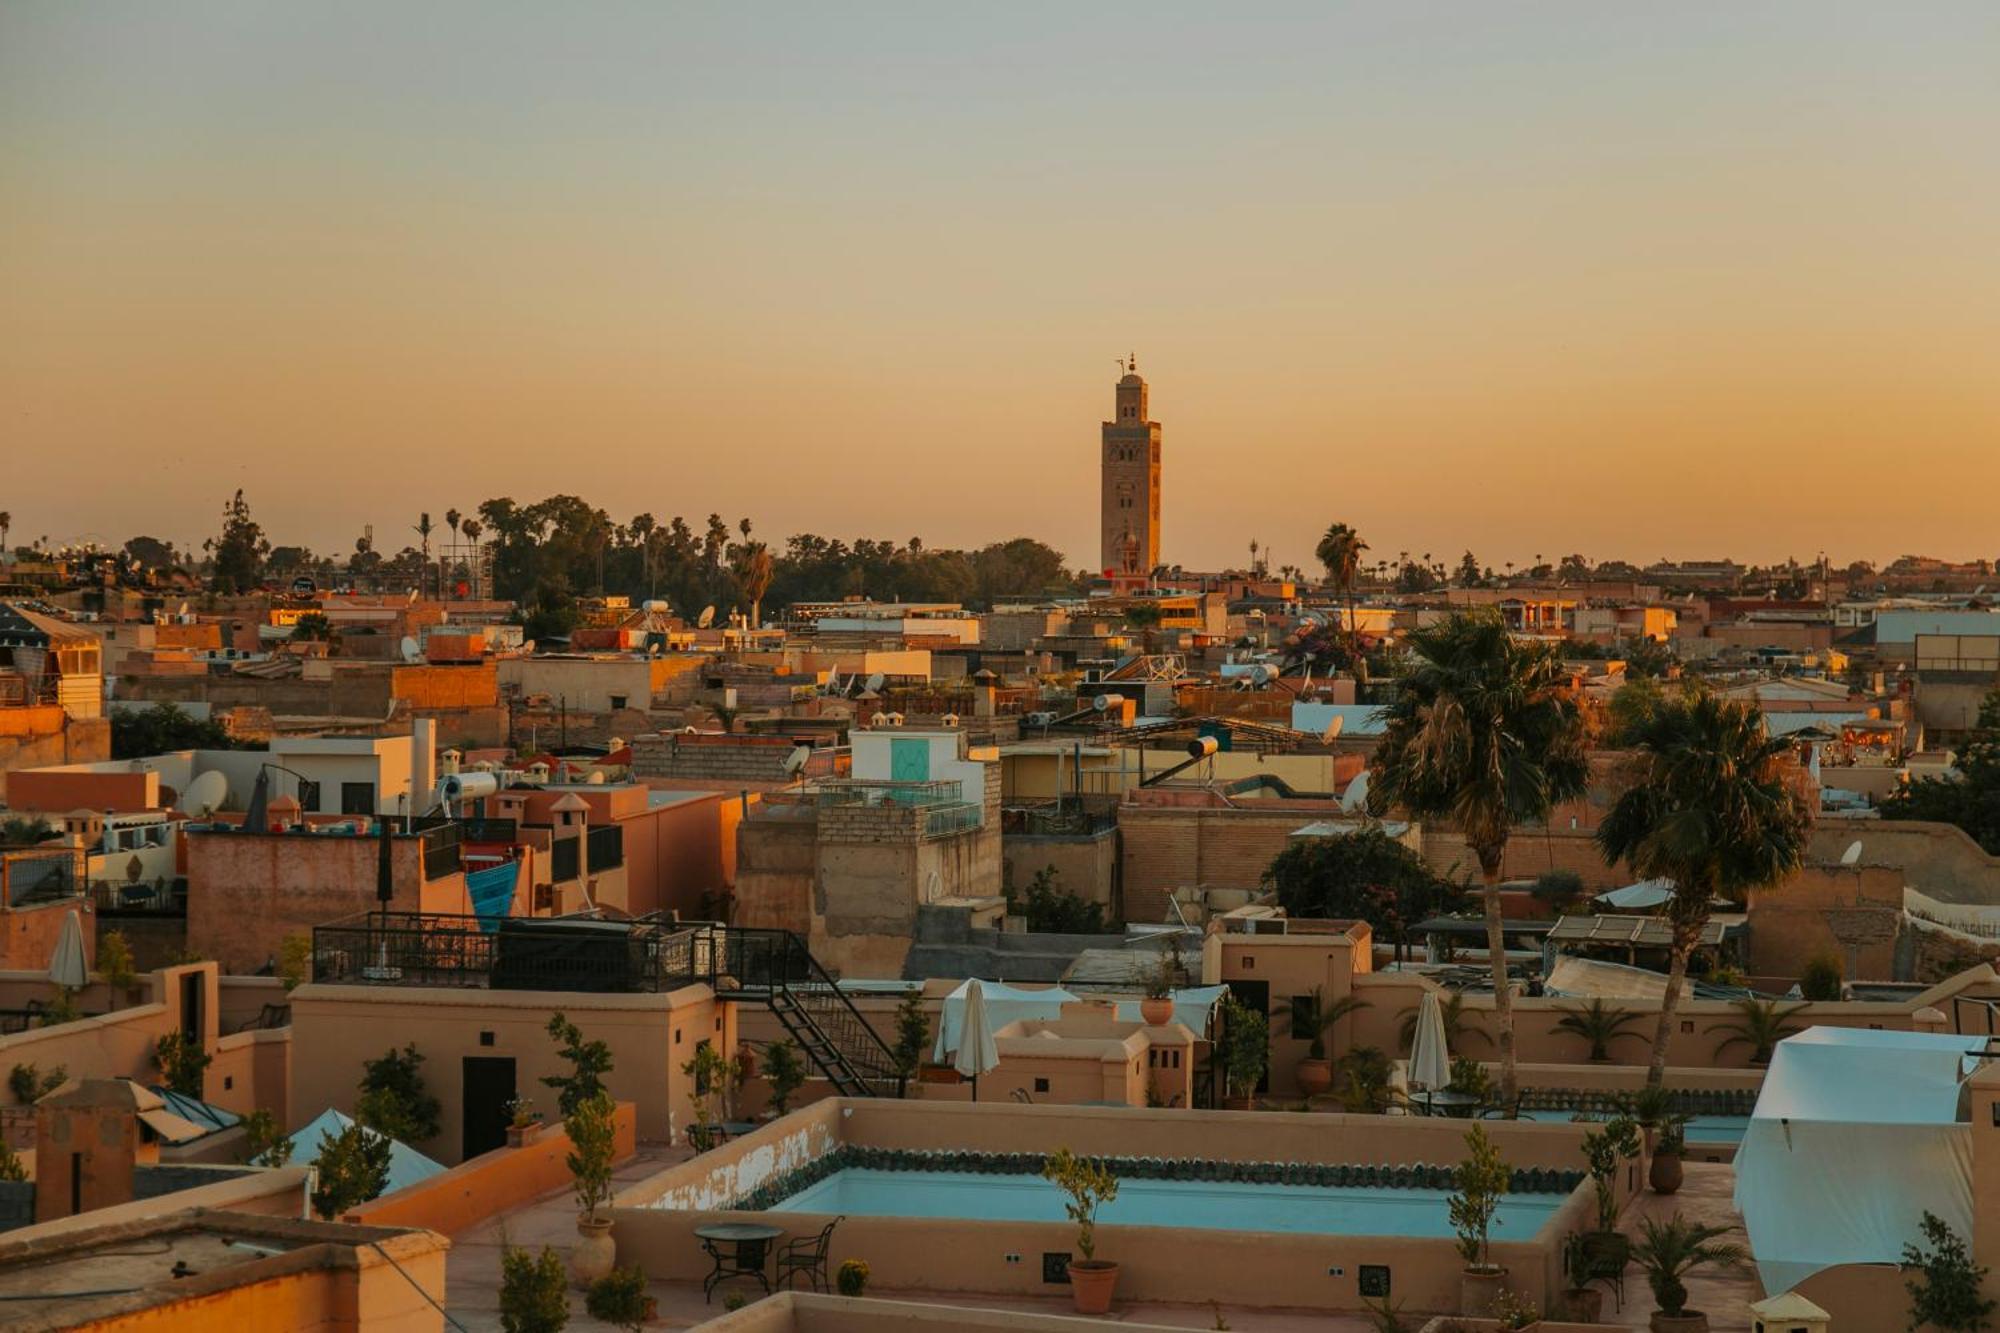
{"left": 1368, "top": 610, "right": 1590, "bottom": 1103}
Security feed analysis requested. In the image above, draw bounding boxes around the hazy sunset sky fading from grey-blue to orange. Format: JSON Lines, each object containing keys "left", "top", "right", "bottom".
{"left": 0, "top": 0, "right": 2000, "bottom": 568}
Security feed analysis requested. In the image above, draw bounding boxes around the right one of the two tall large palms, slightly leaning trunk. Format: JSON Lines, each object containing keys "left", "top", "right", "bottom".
{"left": 1598, "top": 691, "right": 1812, "bottom": 1083}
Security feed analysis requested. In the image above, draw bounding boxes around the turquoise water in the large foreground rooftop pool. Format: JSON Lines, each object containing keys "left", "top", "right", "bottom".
{"left": 772, "top": 1167, "right": 1566, "bottom": 1241}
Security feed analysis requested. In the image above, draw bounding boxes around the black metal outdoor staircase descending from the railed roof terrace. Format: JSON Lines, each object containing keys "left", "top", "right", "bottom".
{"left": 706, "top": 927, "right": 896, "bottom": 1097}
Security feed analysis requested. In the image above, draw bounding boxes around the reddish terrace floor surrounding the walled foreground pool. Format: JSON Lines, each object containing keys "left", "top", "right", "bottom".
{"left": 446, "top": 1145, "right": 1762, "bottom": 1333}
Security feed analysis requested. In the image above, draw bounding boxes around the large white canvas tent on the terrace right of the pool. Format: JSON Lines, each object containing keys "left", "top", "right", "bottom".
{"left": 1736, "top": 1027, "right": 1986, "bottom": 1291}
